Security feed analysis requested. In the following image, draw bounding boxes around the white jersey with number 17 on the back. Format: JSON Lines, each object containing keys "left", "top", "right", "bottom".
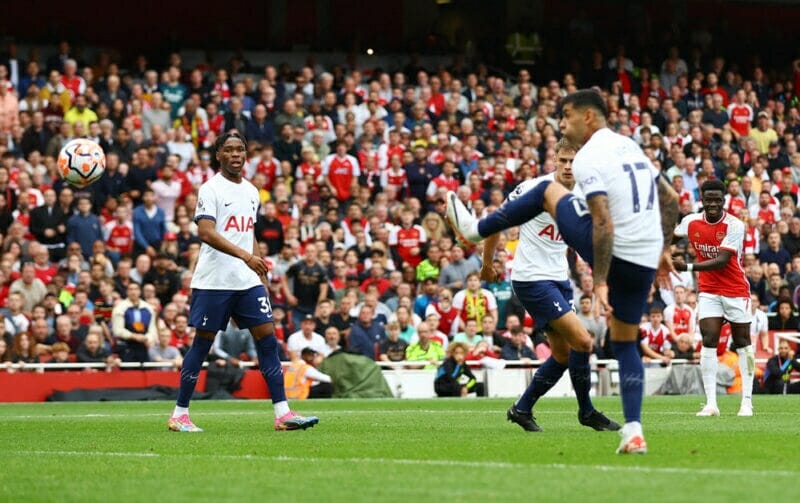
{"left": 572, "top": 128, "right": 664, "bottom": 269}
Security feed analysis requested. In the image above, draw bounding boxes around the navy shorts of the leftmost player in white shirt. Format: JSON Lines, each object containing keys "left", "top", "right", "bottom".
{"left": 189, "top": 285, "right": 272, "bottom": 332}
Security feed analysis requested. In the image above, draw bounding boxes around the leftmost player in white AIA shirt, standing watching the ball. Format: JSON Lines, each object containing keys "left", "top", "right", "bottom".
{"left": 167, "top": 132, "right": 319, "bottom": 432}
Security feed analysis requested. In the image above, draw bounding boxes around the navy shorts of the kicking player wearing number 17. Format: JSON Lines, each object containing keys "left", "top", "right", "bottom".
{"left": 556, "top": 194, "right": 661, "bottom": 325}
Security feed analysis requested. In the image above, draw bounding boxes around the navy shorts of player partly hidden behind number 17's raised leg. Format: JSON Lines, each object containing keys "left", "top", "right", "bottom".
{"left": 511, "top": 281, "right": 574, "bottom": 329}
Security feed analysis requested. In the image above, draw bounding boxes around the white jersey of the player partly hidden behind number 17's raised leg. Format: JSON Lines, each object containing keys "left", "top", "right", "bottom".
{"left": 508, "top": 173, "right": 581, "bottom": 281}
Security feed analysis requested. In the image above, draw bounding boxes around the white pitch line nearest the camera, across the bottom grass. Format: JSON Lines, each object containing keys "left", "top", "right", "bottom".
{"left": 6, "top": 450, "right": 800, "bottom": 478}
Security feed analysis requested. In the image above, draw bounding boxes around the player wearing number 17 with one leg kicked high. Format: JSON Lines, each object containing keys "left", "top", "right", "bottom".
{"left": 445, "top": 90, "right": 678, "bottom": 454}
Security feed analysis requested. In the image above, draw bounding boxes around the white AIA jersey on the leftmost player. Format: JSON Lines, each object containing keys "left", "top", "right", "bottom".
{"left": 191, "top": 173, "right": 262, "bottom": 290}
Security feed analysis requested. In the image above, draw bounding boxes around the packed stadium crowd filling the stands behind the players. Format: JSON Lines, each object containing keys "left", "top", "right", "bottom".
{"left": 0, "top": 42, "right": 800, "bottom": 389}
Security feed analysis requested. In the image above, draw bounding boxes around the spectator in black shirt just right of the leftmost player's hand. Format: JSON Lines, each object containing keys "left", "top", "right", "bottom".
{"left": 281, "top": 245, "right": 328, "bottom": 329}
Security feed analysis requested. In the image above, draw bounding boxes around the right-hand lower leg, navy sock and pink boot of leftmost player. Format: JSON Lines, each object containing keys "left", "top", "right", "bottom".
{"left": 251, "top": 326, "right": 319, "bottom": 431}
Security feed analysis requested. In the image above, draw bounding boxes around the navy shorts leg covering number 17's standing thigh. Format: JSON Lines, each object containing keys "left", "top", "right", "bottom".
{"left": 608, "top": 257, "right": 656, "bottom": 326}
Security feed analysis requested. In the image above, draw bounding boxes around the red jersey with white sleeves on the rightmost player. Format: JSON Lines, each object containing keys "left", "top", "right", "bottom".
{"left": 675, "top": 213, "right": 750, "bottom": 299}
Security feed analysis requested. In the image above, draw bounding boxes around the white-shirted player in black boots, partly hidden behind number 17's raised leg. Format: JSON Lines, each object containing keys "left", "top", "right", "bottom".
{"left": 481, "top": 138, "right": 620, "bottom": 431}
